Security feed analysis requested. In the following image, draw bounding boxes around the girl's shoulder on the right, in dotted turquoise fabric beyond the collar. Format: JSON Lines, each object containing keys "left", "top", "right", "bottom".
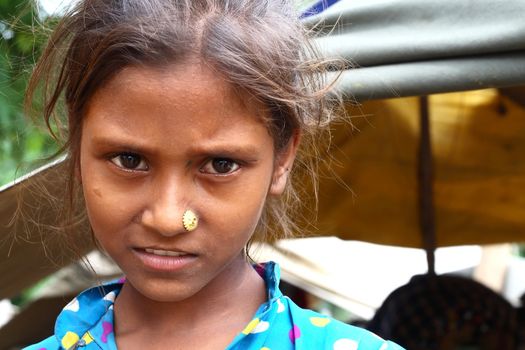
{"left": 282, "top": 297, "right": 403, "bottom": 350}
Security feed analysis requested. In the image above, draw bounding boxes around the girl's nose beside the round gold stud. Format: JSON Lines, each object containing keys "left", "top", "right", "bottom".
{"left": 141, "top": 182, "right": 191, "bottom": 237}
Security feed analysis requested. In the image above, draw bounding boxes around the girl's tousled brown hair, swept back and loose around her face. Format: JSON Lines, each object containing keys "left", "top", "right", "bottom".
{"left": 26, "top": 0, "right": 342, "bottom": 252}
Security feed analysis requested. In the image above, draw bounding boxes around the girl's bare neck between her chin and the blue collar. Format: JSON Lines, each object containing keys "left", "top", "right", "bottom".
{"left": 115, "top": 259, "right": 267, "bottom": 349}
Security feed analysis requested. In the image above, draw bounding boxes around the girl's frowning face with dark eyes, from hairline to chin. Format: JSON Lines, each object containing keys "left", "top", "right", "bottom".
{"left": 80, "top": 62, "right": 297, "bottom": 301}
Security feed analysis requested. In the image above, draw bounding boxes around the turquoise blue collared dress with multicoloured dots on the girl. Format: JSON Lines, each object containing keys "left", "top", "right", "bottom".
{"left": 26, "top": 262, "right": 402, "bottom": 350}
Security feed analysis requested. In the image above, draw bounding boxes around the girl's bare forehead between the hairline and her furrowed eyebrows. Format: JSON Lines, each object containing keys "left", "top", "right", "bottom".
{"left": 85, "top": 64, "right": 268, "bottom": 141}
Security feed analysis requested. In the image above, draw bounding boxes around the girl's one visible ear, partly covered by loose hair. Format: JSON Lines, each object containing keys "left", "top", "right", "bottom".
{"left": 269, "top": 132, "right": 301, "bottom": 196}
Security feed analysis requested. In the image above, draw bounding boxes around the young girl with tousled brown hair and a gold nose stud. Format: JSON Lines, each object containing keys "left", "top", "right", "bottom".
{"left": 23, "top": 0, "right": 399, "bottom": 350}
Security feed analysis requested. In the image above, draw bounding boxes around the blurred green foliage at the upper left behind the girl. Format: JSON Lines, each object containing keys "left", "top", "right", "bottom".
{"left": 0, "top": 0, "right": 56, "bottom": 185}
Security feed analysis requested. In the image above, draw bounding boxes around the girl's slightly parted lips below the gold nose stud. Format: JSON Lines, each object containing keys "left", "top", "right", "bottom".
{"left": 133, "top": 248, "right": 197, "bottom": 272}
